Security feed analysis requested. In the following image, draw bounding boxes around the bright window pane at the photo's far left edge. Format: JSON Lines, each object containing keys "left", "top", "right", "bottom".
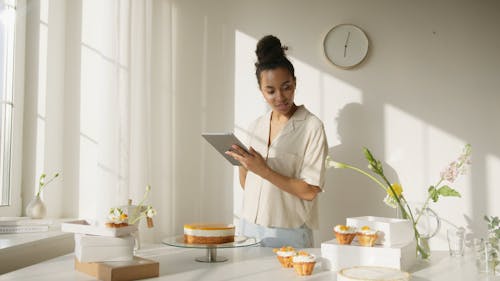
{"left": 0, "top": 1, "right": 16, "bottom": 206}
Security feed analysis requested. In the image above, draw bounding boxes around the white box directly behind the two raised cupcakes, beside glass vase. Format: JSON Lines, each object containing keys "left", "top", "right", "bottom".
{"left": 346, "top": 216, "right": 414, "bottom": 246}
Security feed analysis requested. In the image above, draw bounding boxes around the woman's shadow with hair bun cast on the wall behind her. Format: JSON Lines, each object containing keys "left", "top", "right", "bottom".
{"left": 315, "top": 103, "right": 398, "bottom": 246}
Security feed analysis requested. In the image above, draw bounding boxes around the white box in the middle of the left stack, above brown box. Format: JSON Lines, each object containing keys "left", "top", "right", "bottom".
{"left": 75, "top": 233, "right": 135, "bottom": 262}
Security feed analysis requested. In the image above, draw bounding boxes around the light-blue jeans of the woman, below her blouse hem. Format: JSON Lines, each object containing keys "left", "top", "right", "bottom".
{"left": 240, "top": 218, "right": 313, "bottom": 248}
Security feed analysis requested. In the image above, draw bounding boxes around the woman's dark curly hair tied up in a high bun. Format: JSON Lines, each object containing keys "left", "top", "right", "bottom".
{"left": 255, "top": 35, "right": 295, "bottom": 87}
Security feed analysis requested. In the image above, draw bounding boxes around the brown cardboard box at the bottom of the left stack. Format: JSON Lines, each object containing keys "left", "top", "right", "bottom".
{"left": 75, "top": 257, "right": 160, "bottom": 281}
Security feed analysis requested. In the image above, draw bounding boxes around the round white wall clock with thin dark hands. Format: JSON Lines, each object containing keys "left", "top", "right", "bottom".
{"left": 323, "top": 24, "right": 368, "bottom": 69}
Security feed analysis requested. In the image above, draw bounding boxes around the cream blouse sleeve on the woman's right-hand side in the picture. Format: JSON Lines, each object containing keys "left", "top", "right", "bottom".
{"left": 300, "top": 123, "right": 328, "bottom": 189}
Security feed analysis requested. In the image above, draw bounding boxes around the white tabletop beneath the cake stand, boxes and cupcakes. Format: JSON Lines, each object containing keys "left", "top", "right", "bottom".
{"left": 0, "top": 244, "right": 500, "bottom": 281}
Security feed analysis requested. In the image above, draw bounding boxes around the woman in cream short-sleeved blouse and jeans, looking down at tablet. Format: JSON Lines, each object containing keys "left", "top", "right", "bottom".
{"left": 226, "top": 35, "right": 328, "bottom": 248}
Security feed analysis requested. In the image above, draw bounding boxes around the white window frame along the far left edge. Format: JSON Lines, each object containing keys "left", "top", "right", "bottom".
{"left": 0, "top": 0, "right": 26, "bottom": 216}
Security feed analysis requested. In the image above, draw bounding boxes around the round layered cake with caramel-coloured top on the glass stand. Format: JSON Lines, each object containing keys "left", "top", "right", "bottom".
{"left": 184, "top": 223, "right": 235, "bottom": 244}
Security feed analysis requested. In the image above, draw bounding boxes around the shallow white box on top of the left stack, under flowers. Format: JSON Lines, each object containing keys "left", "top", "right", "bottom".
{"left": 61, "top": 220, "right": 137, "bottom": 237}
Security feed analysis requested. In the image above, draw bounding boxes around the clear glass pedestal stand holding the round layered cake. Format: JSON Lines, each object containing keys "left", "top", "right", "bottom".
{"left": 161, "top": 235, "right": 259, "bottom": 263}
